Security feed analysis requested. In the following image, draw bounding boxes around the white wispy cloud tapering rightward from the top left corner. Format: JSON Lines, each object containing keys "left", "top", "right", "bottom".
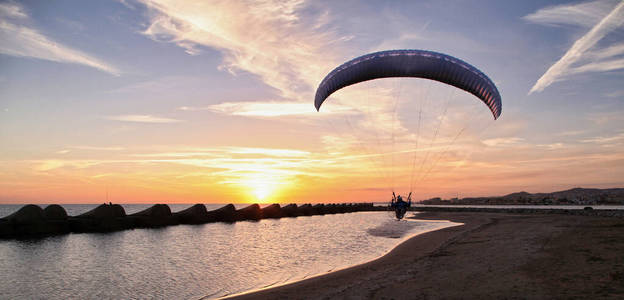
{"left": 0, "top": 2, "right": 121, "bottom": 76}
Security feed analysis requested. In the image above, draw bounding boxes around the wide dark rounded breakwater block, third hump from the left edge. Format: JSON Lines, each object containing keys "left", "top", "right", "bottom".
{"left": 69, "top": 204, "right": 134, "bottom": 232}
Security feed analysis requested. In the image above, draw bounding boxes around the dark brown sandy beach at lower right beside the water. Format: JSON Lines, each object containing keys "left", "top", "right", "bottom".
{"left": 224, "top": 212, "right": 624, "bottom": 299}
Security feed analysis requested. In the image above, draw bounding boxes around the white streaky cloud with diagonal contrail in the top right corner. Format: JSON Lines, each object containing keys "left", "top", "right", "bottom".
{"left": 525, "top": 1, "right": 624, "bottom": 94}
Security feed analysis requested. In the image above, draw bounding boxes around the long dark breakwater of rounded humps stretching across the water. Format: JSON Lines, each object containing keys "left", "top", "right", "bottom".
{"left": 0, "top": 203, "right": 380, "bottom": 239}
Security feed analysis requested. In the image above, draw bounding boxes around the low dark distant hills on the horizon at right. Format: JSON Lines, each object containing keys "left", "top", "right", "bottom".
{"left": 421, "top": 188, "right": 624, "bottom": 205}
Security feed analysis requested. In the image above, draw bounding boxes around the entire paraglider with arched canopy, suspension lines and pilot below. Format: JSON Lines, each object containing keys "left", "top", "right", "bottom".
{"left": 314, "top": 50, "right": 502, "bottom": 204}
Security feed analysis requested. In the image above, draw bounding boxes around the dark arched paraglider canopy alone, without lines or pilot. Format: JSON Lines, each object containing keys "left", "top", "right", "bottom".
{"left": 314, "top": 50, "right": 502, "bottom": 119}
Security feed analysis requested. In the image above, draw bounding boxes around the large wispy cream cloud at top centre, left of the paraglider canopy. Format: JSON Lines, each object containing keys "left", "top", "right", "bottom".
{"left": 141, "top": 0, "right": 341, "bottom": 100}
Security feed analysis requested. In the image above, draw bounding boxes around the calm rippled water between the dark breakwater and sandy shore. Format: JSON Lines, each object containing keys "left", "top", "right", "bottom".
{"left": 0, "top": 209, "right": 456, "bottom": 299}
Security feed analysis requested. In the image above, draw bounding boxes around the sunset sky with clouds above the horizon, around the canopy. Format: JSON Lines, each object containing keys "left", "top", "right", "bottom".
{"left": 0, "top": 0, "right": 624, "bottom": 203}
